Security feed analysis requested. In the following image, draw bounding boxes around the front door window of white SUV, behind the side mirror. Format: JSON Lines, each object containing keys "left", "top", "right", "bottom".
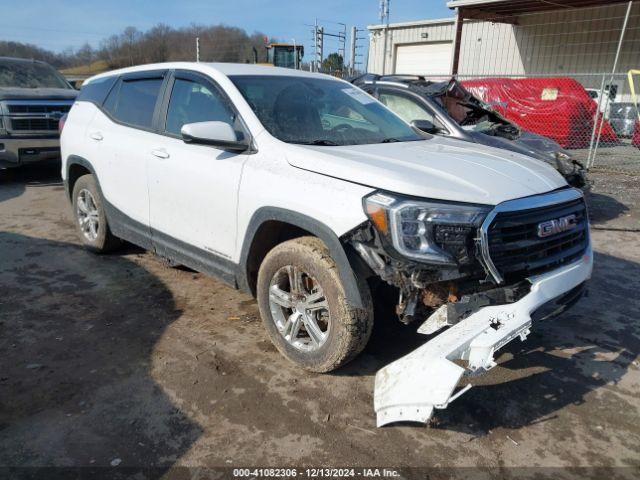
{"left": 165, "top": 78, "right": 235, "bottom": 135}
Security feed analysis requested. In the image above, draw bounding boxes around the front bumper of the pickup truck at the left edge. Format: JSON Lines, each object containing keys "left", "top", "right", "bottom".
{"left": 0, "top": 137, "right": 60, "bottom": 168}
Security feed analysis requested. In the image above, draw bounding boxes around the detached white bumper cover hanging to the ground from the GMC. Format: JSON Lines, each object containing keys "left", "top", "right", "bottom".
{"left": 374, "top": 247, "right": 593, "bottom": 427}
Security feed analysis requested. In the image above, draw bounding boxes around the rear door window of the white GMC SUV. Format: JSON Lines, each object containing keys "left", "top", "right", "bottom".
{"left": 104, "top": 78, "right": 162, "bottom": 129}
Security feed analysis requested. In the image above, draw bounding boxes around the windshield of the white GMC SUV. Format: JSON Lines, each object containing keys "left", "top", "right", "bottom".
{"left": 230, "top": 75, "right": 425, "bottom": 146}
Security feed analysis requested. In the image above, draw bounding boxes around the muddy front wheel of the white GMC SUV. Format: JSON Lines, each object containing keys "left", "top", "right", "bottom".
{"left": 257, "top": 237, "right": 373, "bottom": 372}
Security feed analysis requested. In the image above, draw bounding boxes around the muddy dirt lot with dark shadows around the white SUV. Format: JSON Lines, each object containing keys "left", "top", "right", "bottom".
{"left": 0, "top": 164, "right": 640, "bottom": 478}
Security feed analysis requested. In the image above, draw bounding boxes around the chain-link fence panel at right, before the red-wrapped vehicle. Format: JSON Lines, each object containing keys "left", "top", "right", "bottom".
{"left": 458, "top": 2, "right": 640, "bottom": 175}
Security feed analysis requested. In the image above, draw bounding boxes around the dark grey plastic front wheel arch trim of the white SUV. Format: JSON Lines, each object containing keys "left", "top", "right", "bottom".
{"left": 237, "top": 207, "right": 364, "bottom": 308}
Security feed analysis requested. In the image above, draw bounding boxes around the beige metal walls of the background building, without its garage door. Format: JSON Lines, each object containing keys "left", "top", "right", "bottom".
{"left": 368, "top": 2, "right": 640, "bottom": 79}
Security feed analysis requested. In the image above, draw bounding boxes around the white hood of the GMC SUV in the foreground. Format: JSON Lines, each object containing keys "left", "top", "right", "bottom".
{"left": 287, "top": 136, "right": 566, "bottom": 205}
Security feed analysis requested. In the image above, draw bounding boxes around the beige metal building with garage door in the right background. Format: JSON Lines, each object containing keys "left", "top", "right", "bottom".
{"left": 368, "top": 0, "right": 640, "bottom": 81}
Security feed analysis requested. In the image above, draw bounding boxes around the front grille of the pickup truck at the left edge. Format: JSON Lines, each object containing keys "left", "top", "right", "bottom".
{"left": 5, "top": 100, "right": 72, "bottom": 135}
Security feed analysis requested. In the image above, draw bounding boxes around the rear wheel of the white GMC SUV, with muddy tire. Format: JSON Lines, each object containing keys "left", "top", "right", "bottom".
{"left": 71, "top": 174, "right": 122, "bottom": 253}
